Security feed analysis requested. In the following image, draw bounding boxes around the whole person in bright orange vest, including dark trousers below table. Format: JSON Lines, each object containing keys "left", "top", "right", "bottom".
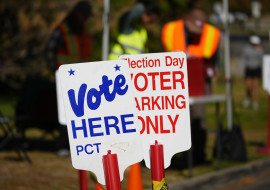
{"left": 161, "top": 1, "right": 220, "bottom": 164}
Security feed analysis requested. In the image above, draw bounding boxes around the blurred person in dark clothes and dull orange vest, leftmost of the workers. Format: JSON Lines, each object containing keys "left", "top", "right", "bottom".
{"left": 45, "top": 1, "right": 92, "bottom": 157}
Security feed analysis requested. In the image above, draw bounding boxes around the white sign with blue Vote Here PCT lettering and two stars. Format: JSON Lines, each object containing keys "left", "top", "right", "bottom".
{"left": 60, "top": 60, "right": 143, "bottom": 184}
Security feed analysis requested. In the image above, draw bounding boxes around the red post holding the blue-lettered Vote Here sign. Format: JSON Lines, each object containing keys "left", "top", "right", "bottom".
{"left": 103, "top": 150, "right": 121, "bottom": 190}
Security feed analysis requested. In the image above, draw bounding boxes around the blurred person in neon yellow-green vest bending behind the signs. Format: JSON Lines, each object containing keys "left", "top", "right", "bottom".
{"left": 108, "top": 2, "right": 160, "bottom": 60}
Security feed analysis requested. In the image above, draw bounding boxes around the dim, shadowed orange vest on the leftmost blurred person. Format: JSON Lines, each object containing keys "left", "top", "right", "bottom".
{"left": 57, "top": 24, "right": 91, "bottom": 67}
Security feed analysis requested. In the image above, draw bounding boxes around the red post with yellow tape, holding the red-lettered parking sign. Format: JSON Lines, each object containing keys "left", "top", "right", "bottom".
{"left": 150, "top": 140, "right": 168, "bottom": 190}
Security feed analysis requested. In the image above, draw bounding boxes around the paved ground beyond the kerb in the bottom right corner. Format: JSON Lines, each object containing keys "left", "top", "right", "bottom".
{"left": 168, "top": 159, "right": 270, "bottom": 190}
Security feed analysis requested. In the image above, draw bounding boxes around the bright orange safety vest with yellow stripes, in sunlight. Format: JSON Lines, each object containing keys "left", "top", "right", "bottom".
{"left": 161, "top": 20, "right": 220, "bottom": 58}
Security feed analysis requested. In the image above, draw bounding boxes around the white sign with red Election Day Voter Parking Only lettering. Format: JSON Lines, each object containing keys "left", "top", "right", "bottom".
{"left": 119, "top": 52, "right": 191, "bottom": 168}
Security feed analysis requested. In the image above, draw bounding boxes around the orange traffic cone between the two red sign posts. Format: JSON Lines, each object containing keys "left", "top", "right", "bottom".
{"left": 127, "top": 163, "right": 143, "bottom": 190}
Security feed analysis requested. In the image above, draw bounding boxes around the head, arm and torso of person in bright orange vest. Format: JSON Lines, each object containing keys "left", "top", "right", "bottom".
{"left": 161, "top": 5, "right": 220, "bottom": 94}
